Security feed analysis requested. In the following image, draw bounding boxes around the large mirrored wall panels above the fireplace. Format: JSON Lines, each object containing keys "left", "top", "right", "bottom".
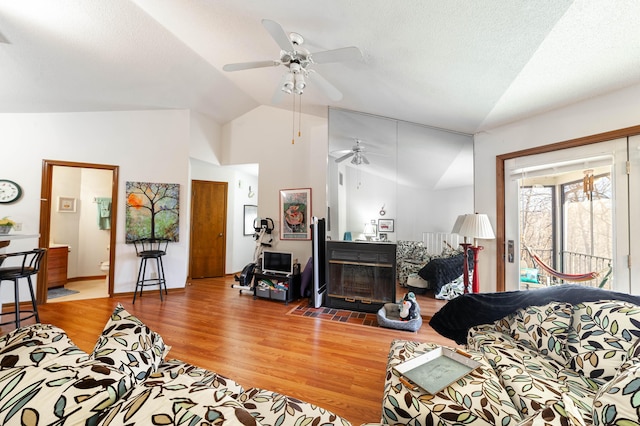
{"left": 327, "top": 108, "right": 473, "bottom": 241}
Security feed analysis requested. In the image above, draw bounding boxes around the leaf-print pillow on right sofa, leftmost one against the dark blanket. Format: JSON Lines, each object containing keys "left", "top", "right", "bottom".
{"left": 511, "top": 302, "right": 573, "bottom": 365}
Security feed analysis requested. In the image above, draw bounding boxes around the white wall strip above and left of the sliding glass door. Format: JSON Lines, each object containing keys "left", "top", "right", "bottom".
{"left": 474, "top": 80, "right": 640, "bottom": 292}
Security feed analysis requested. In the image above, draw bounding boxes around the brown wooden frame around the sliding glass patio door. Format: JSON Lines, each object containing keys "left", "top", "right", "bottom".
{"left": 496, "top": 126, "right": 640, "bottom": 291}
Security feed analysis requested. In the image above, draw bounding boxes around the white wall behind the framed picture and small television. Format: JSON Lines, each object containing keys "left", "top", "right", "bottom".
{"left": 222, "top": 106, "right": 328, "bottom": 265}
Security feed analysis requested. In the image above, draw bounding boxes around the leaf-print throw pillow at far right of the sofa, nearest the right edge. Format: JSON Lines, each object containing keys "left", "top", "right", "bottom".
{"left": 567, "top": 300, "right": 640, "bottom": 384}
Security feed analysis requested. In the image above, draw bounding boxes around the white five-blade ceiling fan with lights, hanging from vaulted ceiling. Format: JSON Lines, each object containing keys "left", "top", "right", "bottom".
{"left": 222, "top": 19, "right": 362, "bottom": 101}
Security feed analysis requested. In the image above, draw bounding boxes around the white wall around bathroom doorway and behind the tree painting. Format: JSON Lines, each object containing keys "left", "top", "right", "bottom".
{"left": 0, "top": 110, "right": 190, "bottom": 300}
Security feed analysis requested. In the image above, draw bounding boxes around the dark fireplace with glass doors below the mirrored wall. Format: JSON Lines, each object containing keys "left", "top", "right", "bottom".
{"left": 326, "top": 241, "right": 396, "bottom": 312}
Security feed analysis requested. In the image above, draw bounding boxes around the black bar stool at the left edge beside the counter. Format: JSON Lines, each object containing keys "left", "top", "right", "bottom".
{"left": 0, "top": 248, "right": 47, "bottom": 328}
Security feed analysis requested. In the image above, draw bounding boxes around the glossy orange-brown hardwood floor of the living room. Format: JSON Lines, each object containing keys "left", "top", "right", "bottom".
{"left": 17, "top": 277, "right": 455, "bottom": 425}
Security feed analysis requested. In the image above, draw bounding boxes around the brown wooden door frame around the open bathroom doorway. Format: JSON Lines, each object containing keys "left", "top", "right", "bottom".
{"left": 36, "top": 159, "right": 119, "bottom": 305}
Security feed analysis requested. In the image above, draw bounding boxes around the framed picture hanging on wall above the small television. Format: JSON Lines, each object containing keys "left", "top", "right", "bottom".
{"left": 280, "top": 188, "right": 311, "bottom": 240}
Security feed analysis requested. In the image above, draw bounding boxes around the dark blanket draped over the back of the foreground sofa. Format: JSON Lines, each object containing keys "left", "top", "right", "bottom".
{"left": 429, "top": 284, "right": 640, "bottom": 345}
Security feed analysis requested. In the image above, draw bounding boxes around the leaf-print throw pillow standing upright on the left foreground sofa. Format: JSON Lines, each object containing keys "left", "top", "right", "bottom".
{"left": 91, "top": 303, "right": 170, "bottom": 383}
